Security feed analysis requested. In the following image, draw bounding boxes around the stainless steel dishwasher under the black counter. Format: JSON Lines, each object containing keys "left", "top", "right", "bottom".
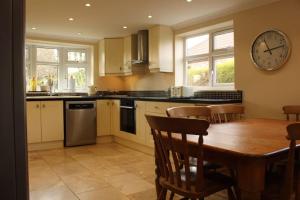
{"left": 65, "top": 101, "right": 97, "bottom": 147}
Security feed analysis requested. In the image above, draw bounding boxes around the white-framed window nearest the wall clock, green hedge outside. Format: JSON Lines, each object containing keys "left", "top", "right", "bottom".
{"left": 184, "top": 29, "right": 234, "bottom": 88}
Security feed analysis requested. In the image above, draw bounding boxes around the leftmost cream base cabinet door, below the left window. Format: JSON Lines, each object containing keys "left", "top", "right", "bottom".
{"left": 26, "top": 101, "right": 42, "bottom": 143}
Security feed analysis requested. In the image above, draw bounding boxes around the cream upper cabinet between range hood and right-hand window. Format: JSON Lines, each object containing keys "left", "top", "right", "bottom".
{"left": 149, "top": 25, "right": 174, "bottom": 72}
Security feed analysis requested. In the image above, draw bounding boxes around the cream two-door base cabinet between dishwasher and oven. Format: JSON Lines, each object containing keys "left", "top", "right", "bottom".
{"left": 97, "top": 100, "right": 120, "bottom": 136}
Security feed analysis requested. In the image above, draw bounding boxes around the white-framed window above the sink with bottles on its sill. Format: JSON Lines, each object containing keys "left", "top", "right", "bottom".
{"left": 25, "top": 44, "right": 92, "bottom": 92}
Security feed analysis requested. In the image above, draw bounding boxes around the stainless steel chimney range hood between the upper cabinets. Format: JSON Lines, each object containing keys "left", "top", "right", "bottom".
{"left": 132, "top": 30, "right": 149, "bottom": 64}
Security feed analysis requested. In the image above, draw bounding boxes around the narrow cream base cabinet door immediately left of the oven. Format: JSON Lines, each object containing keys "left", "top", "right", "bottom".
{"left": 110, "top": 100, "right": 120, "bottom": 135}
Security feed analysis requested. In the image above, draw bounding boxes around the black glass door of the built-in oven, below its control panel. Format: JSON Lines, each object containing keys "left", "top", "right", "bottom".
{"left": 120, "top": 106, "right": 135, "bottom": 134}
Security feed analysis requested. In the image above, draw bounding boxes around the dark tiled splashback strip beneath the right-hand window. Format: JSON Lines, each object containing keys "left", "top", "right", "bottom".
{"left": 194, "top": 90, "right": 243, "bottom": 101}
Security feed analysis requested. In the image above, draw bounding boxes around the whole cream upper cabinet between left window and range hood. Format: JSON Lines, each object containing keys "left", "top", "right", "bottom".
{"left": 99, "top": 38, "right": 130, "bottom": 76}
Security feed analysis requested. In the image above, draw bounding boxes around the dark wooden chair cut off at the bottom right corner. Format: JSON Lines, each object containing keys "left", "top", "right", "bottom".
{"left": 263, "top": 123, "right": 300, "bottom": 200}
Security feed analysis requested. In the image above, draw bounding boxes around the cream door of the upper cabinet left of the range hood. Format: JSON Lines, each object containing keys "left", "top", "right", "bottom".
{"left": 105, "top": 38, "right": 124, "bottom": 74}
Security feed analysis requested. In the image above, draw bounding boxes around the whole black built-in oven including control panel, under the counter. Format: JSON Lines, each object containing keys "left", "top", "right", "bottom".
{"left": 120, "top": 98, "right": 135, "bottom": 134}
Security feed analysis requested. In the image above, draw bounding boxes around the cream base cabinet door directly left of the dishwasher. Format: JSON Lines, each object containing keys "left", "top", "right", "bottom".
{"left": 41, "top": 101, "right": 64, "bottom": 142}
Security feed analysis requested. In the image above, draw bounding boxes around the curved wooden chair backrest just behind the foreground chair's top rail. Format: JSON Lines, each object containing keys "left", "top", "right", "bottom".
{"left": 167, "top": 106, "right": 211, "bottom": 121}
